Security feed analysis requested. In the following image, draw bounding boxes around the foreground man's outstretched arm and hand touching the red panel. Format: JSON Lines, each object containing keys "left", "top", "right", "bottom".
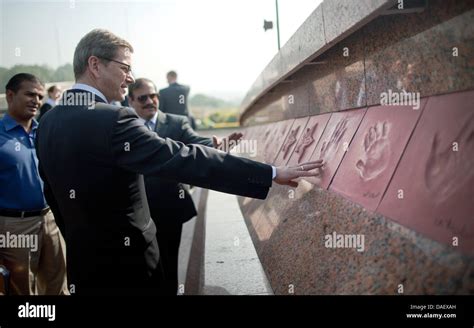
{"left": 111, "top": 108, "right": 322, "bottom": 199}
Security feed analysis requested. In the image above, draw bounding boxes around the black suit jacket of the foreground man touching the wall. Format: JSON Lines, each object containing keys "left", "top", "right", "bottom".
{"left": 36, "top": 90, "right": 272, "bottom": 294}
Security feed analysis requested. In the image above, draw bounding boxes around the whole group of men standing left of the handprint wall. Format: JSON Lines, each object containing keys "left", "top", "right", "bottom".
{"left": 0, "top": 29, "right": 322, "bottom": 295}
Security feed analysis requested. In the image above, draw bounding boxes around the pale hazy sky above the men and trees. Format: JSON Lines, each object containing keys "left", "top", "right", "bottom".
{"left": 0, "top": 0, "right": 322, "bottom": 100}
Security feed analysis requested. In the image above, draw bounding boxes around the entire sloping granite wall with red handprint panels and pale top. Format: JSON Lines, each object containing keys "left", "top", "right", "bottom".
{"left": 239, "top": 0, "right": 474, "bottom": 294}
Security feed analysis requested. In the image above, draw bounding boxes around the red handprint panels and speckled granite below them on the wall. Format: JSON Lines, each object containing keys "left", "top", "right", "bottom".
{"left": 239, "top": 91, "right": 474, "bottom": 294}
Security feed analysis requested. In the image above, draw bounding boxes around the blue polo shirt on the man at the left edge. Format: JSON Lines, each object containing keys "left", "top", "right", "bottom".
{"left": 0, "top": 114, "right": 47, "bottom": 211}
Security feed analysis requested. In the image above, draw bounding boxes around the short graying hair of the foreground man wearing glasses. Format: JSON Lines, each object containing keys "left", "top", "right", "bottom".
{"left": 73, "top": 29, "right": 133, "bottom": 80}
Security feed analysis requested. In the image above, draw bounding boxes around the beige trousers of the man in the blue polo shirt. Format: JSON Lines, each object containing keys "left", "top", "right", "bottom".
{"left": 0, "top": 211, "right": 69, "bottom": 295}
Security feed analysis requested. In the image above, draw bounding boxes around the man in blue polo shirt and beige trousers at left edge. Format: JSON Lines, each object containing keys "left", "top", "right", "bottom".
{"left": 0, "top": 73, "right": 68, "bottom": 295}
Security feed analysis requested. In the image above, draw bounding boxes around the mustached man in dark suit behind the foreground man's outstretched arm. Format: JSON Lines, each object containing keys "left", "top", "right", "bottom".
{"left": 128, "top": 78, "right": 242, "bottom": 295}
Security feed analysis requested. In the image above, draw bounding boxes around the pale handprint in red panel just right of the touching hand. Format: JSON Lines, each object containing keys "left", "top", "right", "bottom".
{"left": 356, "top": 121, "right": 390, "bottom": 181}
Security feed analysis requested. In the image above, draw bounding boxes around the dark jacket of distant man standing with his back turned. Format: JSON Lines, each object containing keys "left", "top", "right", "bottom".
{"left": 160, "top": 83, "right": 189, "bottom": 116}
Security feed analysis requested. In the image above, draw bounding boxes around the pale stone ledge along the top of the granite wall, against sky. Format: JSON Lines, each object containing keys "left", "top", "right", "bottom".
{"left": 241, "top": 0, "right": 396, "bottom": 119}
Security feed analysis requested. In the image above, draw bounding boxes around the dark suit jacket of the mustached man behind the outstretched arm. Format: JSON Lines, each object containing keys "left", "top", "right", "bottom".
{"left": 145, "top": 110, "right": 213, "bottom": 223}
